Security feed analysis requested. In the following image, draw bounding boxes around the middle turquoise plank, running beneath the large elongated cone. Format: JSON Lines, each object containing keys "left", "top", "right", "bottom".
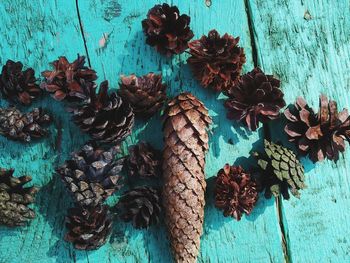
{"left": 79, "top": 0, "right": 283, "bottom": 262}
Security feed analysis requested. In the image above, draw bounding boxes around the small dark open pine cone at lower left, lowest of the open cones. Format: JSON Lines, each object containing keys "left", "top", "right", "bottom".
{"left": 65, "top": 205, "right": 112, "bottom": 250}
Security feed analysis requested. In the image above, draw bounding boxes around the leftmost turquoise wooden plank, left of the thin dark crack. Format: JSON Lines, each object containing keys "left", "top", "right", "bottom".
{"left": 0, "top": 0, "right": 87, "bottom": 263}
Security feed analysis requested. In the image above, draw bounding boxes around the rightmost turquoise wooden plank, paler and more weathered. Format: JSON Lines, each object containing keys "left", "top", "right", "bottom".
{"left": 249, "top": 0, "right": 350, "bottom": 262}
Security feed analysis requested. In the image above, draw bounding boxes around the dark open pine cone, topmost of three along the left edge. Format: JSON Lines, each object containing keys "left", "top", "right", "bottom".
{"left": 0, "top": 60, "right": 41, "bottom": 105}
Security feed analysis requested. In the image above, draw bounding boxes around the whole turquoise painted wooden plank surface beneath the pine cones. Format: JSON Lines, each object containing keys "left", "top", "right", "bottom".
{"left": 0, "top": 0, "right": 350, "bottom": 263}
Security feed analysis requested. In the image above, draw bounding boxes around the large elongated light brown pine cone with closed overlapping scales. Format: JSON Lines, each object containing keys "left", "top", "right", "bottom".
{"left": 163, "top": 93, "right": 211, "bottom": 262}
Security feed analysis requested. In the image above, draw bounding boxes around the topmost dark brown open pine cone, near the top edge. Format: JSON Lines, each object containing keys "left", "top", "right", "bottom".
{"left": 142, "top": 3, "right": 193, "bottom": 56}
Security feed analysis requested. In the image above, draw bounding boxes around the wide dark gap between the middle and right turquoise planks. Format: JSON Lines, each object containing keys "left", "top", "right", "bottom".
{"left": 244, "top": 0, "right": 291, "bottom": 263}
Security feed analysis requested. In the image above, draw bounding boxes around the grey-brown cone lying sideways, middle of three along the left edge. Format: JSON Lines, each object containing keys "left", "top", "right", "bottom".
{"left": 0, "top": 107, "right": 51, "bottom": 142}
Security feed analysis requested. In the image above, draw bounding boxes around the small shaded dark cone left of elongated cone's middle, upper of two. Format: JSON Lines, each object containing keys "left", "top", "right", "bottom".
{"left": 125, "top": 142, "right": 162, "bottom": 178}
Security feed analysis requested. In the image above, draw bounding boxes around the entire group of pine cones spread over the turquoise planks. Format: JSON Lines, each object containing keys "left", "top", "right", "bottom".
{"left": 0, "top": 4, "right": 350, "bottom": 262}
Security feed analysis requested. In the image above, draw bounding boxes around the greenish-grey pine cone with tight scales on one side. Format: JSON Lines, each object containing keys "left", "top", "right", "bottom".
{"left": 254, "top": 140, "right": 306, "bottom": 199}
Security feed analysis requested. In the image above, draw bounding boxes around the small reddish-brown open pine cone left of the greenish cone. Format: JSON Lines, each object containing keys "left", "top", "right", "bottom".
{"left": 215, "top": 164, "right": 258, "bottom": 221}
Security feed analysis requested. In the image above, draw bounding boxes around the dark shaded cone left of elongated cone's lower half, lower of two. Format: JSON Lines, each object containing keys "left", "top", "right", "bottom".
{"left": 116, "top": 186, "right": 162, "bottom": 229}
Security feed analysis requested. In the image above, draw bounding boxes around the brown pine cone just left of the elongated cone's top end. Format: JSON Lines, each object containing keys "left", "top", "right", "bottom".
{"left": 118, "top": 73, "right": 166, "bottom": 119}
